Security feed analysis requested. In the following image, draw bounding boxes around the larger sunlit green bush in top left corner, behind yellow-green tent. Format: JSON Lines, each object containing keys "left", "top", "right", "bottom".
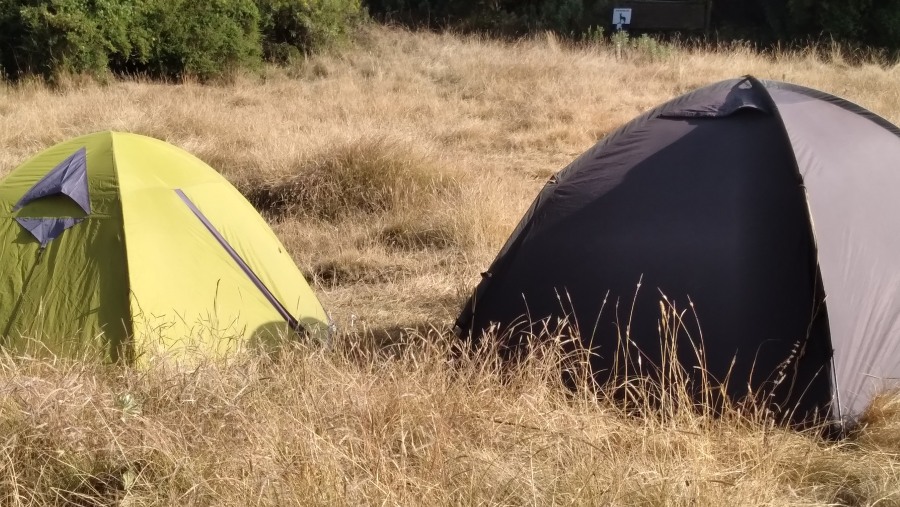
{"left": 0, "top": 0, "right": 260, "bottom": 79}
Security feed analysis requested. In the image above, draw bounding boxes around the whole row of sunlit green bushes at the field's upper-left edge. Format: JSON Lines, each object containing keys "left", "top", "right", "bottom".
{"left": 0, "top": 0, "right": 363, "bottom": 79}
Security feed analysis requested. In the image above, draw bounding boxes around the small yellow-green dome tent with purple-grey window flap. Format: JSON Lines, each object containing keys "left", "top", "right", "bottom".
{"left": 0, "top": 132, "right": 329, "bottom": 361}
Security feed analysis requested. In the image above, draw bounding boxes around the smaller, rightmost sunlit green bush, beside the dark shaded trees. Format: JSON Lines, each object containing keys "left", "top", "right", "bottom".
{"left": 256, "top": 0, "right": 364, "bottom": 62}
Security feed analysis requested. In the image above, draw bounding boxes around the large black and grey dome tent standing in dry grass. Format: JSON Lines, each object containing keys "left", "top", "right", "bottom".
{"left": 457, "top": 77, "right": 900, "bottom": 428}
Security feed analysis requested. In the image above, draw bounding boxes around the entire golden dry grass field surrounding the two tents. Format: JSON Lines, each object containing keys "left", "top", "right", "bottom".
{"left": 0, "top": 27, "right": 900, "bottom": 506}
